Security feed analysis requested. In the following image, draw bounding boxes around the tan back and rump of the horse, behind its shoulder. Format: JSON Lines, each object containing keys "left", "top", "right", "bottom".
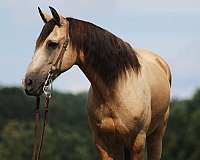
{"left": 135, "top": 49, "right": 171, "bottom": 133}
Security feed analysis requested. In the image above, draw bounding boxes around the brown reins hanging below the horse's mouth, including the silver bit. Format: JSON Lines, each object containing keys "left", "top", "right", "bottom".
{"left": 32, "top": 72, "right": 53, "bottom": 160}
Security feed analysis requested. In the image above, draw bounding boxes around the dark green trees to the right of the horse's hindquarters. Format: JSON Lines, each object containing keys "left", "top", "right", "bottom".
{"left": 163, "top": 90, "right": 200, "bottom": 160}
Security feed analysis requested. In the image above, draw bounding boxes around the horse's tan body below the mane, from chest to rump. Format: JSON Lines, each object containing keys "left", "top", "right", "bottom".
{"left": 88, "top": 49, "right": 171, "bottom": 160}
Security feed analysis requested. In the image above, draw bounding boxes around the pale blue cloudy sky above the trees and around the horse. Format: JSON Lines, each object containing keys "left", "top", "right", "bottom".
{"left": 0, "top": 0, "right": 200, "bottom": 98}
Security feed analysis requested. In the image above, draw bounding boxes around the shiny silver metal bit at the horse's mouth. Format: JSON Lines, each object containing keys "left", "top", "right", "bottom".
{"left": 43, "top": 72, "right": 53, "bottom": 98}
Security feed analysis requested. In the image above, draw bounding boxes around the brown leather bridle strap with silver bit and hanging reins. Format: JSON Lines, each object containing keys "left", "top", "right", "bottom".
{"left": 32, "top": 39, "right": 68, "bottom": 160}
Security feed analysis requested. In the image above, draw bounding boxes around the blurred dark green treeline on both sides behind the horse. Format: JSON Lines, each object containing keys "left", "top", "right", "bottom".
{"left": 0, "top": 88, "right": 200, "bottom": 160}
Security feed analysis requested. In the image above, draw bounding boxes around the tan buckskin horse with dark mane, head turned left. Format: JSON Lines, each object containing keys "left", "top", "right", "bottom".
{"left": 24, "top": 7, "right": 171, "bottom": 160}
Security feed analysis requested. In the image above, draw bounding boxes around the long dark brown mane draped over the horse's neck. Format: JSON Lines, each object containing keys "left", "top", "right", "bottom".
{"left": 66, "top": 18, "right": 140, "bottom": 85}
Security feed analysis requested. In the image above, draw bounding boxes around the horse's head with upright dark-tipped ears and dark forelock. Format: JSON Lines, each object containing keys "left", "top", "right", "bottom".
{"left": 23, "top": 7, "right": 77, "bottom": 96}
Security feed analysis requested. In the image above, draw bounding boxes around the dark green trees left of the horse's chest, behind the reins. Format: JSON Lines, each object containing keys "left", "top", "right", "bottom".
{"left": 0, "top": 88, "right": 97, "bottom": 160}
